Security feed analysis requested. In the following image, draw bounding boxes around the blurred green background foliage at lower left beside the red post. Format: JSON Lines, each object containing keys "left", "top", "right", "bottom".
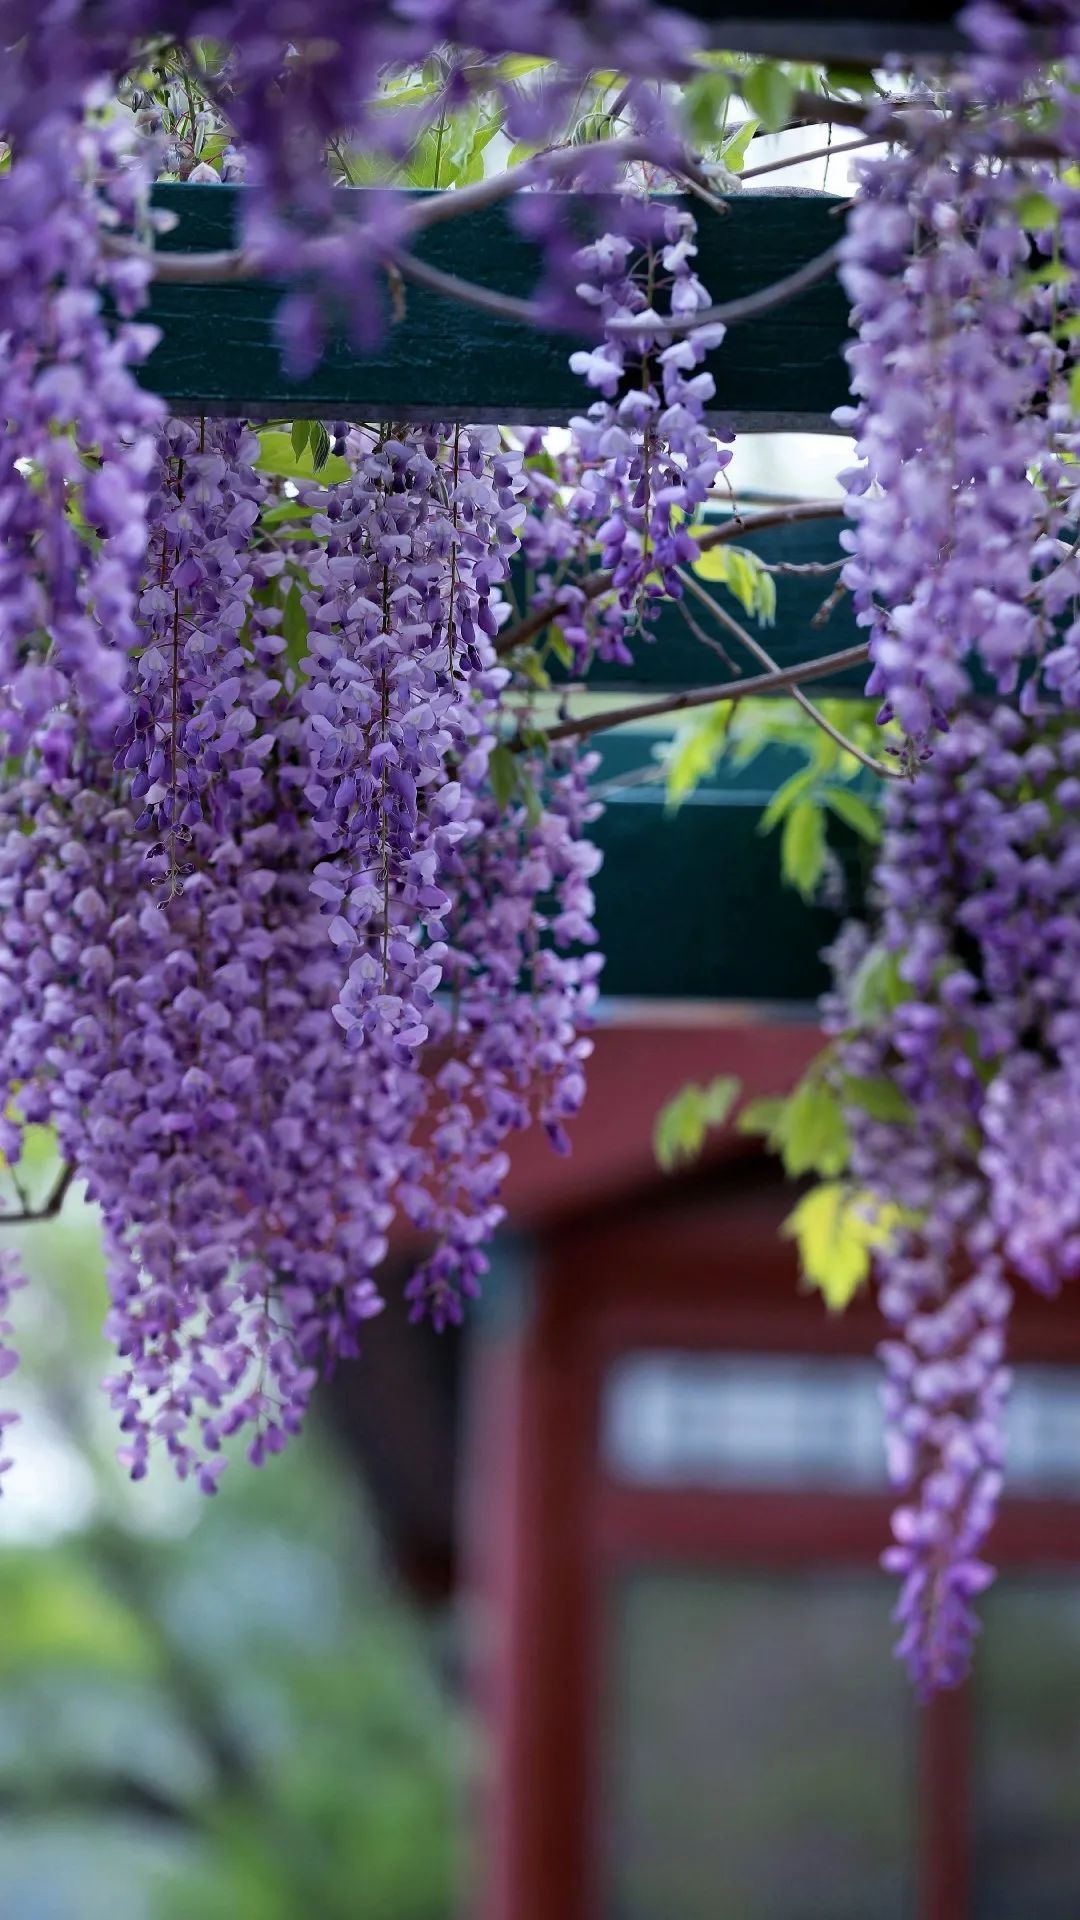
{"left": 0, "top": 1146, "right": 469, "bottom": 1920}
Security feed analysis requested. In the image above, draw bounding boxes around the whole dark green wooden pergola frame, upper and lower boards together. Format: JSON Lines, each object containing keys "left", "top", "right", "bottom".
{"left": 144, "top": 180, "right": 865, "bottom": 1002}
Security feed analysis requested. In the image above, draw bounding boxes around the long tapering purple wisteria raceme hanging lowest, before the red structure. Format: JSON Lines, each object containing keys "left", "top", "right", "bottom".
{"left": 830, "top": 707, "right": 1080, "bottom": 1690}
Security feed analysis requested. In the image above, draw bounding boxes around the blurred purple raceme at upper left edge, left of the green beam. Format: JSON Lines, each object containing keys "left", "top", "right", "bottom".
{"left": 0, "top": 117, "right": 160, "bottom": 753}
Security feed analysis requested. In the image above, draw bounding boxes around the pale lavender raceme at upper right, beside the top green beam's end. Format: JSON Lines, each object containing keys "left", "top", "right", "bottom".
{"left": 838, "top": 156, "right": 1065, "bottom": 756}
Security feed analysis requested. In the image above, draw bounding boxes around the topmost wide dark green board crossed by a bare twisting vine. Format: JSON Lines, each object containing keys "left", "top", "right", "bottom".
{"left": 144, "top": 186, "right": 847, "bottom": 430}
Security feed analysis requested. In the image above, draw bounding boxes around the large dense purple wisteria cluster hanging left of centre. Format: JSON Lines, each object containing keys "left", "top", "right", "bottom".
{"left": 0, "top": 420, "right": 600, "bottom": 1490}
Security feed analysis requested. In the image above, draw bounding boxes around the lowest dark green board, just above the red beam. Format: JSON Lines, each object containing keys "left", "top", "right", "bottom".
{"left": 594, "top": 733, "right": 863, "bottom": 1002}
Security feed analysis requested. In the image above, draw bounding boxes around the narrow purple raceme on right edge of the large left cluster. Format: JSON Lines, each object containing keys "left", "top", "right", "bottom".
{"left": 402, "top": 751, "right": 603, "bottom": 1327}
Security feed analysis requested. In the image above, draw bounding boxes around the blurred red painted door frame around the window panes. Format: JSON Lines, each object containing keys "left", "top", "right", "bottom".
{"left": 467, "top": 1165, "right": 1080, "bottom": 1920}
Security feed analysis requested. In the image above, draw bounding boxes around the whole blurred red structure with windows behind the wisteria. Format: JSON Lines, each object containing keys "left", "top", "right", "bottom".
{"left": 457, "top": 1016, "right": 1080, "bottom": 1920}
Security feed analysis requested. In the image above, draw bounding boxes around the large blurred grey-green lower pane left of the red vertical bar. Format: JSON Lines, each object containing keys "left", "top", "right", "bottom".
{"left": 603, "top": 1569, "right": 910, "bottom": 1920}
